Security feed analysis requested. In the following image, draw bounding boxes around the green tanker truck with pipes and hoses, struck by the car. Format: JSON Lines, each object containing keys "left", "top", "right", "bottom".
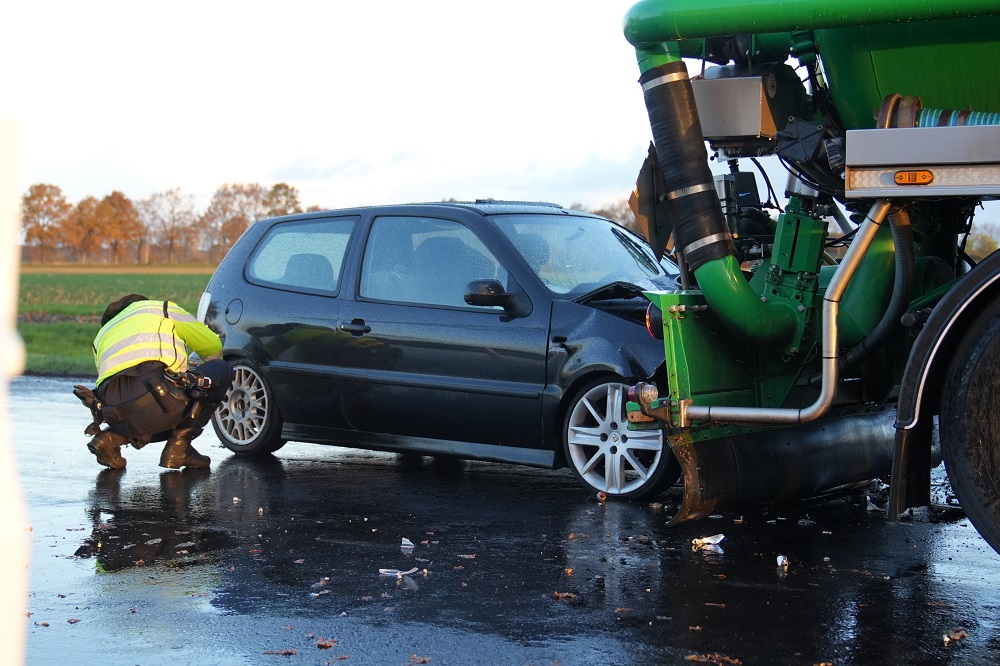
{"left": 624, "top": 0, "right": 1000, "bottom": 551}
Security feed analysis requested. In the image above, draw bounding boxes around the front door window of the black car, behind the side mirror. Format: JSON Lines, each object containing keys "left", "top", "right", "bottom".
{"left": 360, "top": 217, "right": 508, "bottom": 311}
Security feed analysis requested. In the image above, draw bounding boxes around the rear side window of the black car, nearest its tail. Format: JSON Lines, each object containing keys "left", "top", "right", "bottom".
{"left": 246, "top": 217, "right": 358, "bottom": 295}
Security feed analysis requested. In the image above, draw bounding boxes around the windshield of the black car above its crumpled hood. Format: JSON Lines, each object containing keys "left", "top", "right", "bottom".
{"left": 493, "top": 215, "right": 676, "bottom": 298}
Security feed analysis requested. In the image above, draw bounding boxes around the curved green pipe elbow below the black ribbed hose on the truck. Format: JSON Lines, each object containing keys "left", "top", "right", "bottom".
{"left": 694, "top": 255, "right": 796, "bottom": 346}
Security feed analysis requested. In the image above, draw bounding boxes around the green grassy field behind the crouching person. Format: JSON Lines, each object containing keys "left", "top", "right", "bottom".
{"left": 17, "top": 266, "right": 214, "bottom": 376}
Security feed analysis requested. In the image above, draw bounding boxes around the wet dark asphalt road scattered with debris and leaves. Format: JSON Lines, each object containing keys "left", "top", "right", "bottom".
{"left": 10, "top": 378, "right": 1000, "bottom": 666}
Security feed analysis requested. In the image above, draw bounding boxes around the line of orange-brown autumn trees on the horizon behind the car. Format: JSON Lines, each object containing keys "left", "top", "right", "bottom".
{"left": 21, "top": 183, "right": 637, "bottom": 264}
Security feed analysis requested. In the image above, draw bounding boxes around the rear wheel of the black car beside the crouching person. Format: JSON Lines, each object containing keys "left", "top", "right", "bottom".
{"left": 212, "top": 360, "right": 285, "bottom": 456}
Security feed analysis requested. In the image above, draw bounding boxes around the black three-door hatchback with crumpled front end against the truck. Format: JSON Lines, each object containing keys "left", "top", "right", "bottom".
{"left": 199, "top": 201, "right": 679, "bottom": 497}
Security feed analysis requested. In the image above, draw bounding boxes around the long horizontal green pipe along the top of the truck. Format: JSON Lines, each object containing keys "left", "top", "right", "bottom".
{"left": 623, "top": 0, "right": 1000, "bottom": 47}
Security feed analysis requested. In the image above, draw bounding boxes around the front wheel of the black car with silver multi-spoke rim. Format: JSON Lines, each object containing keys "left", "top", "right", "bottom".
{"left": 562, "top": 377, "right": 681, "bottom": 499}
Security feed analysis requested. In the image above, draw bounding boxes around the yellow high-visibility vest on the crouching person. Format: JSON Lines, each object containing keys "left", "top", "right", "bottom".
{"left": 94, "top": 301, "right": 222, "bottom": 385}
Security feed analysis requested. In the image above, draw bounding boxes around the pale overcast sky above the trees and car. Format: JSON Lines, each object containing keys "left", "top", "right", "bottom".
{"left": 0, "top": 0, "right": 672, "bottom": 207}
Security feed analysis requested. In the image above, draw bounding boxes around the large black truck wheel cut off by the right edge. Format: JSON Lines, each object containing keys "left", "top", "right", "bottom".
{"left": 941, "top": 302, "right": 1000, "bottom": 552}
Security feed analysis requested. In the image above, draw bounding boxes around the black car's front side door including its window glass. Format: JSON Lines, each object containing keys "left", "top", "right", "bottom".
{"left": 341, "top": 216, "right": 549, "bottom": 447}
